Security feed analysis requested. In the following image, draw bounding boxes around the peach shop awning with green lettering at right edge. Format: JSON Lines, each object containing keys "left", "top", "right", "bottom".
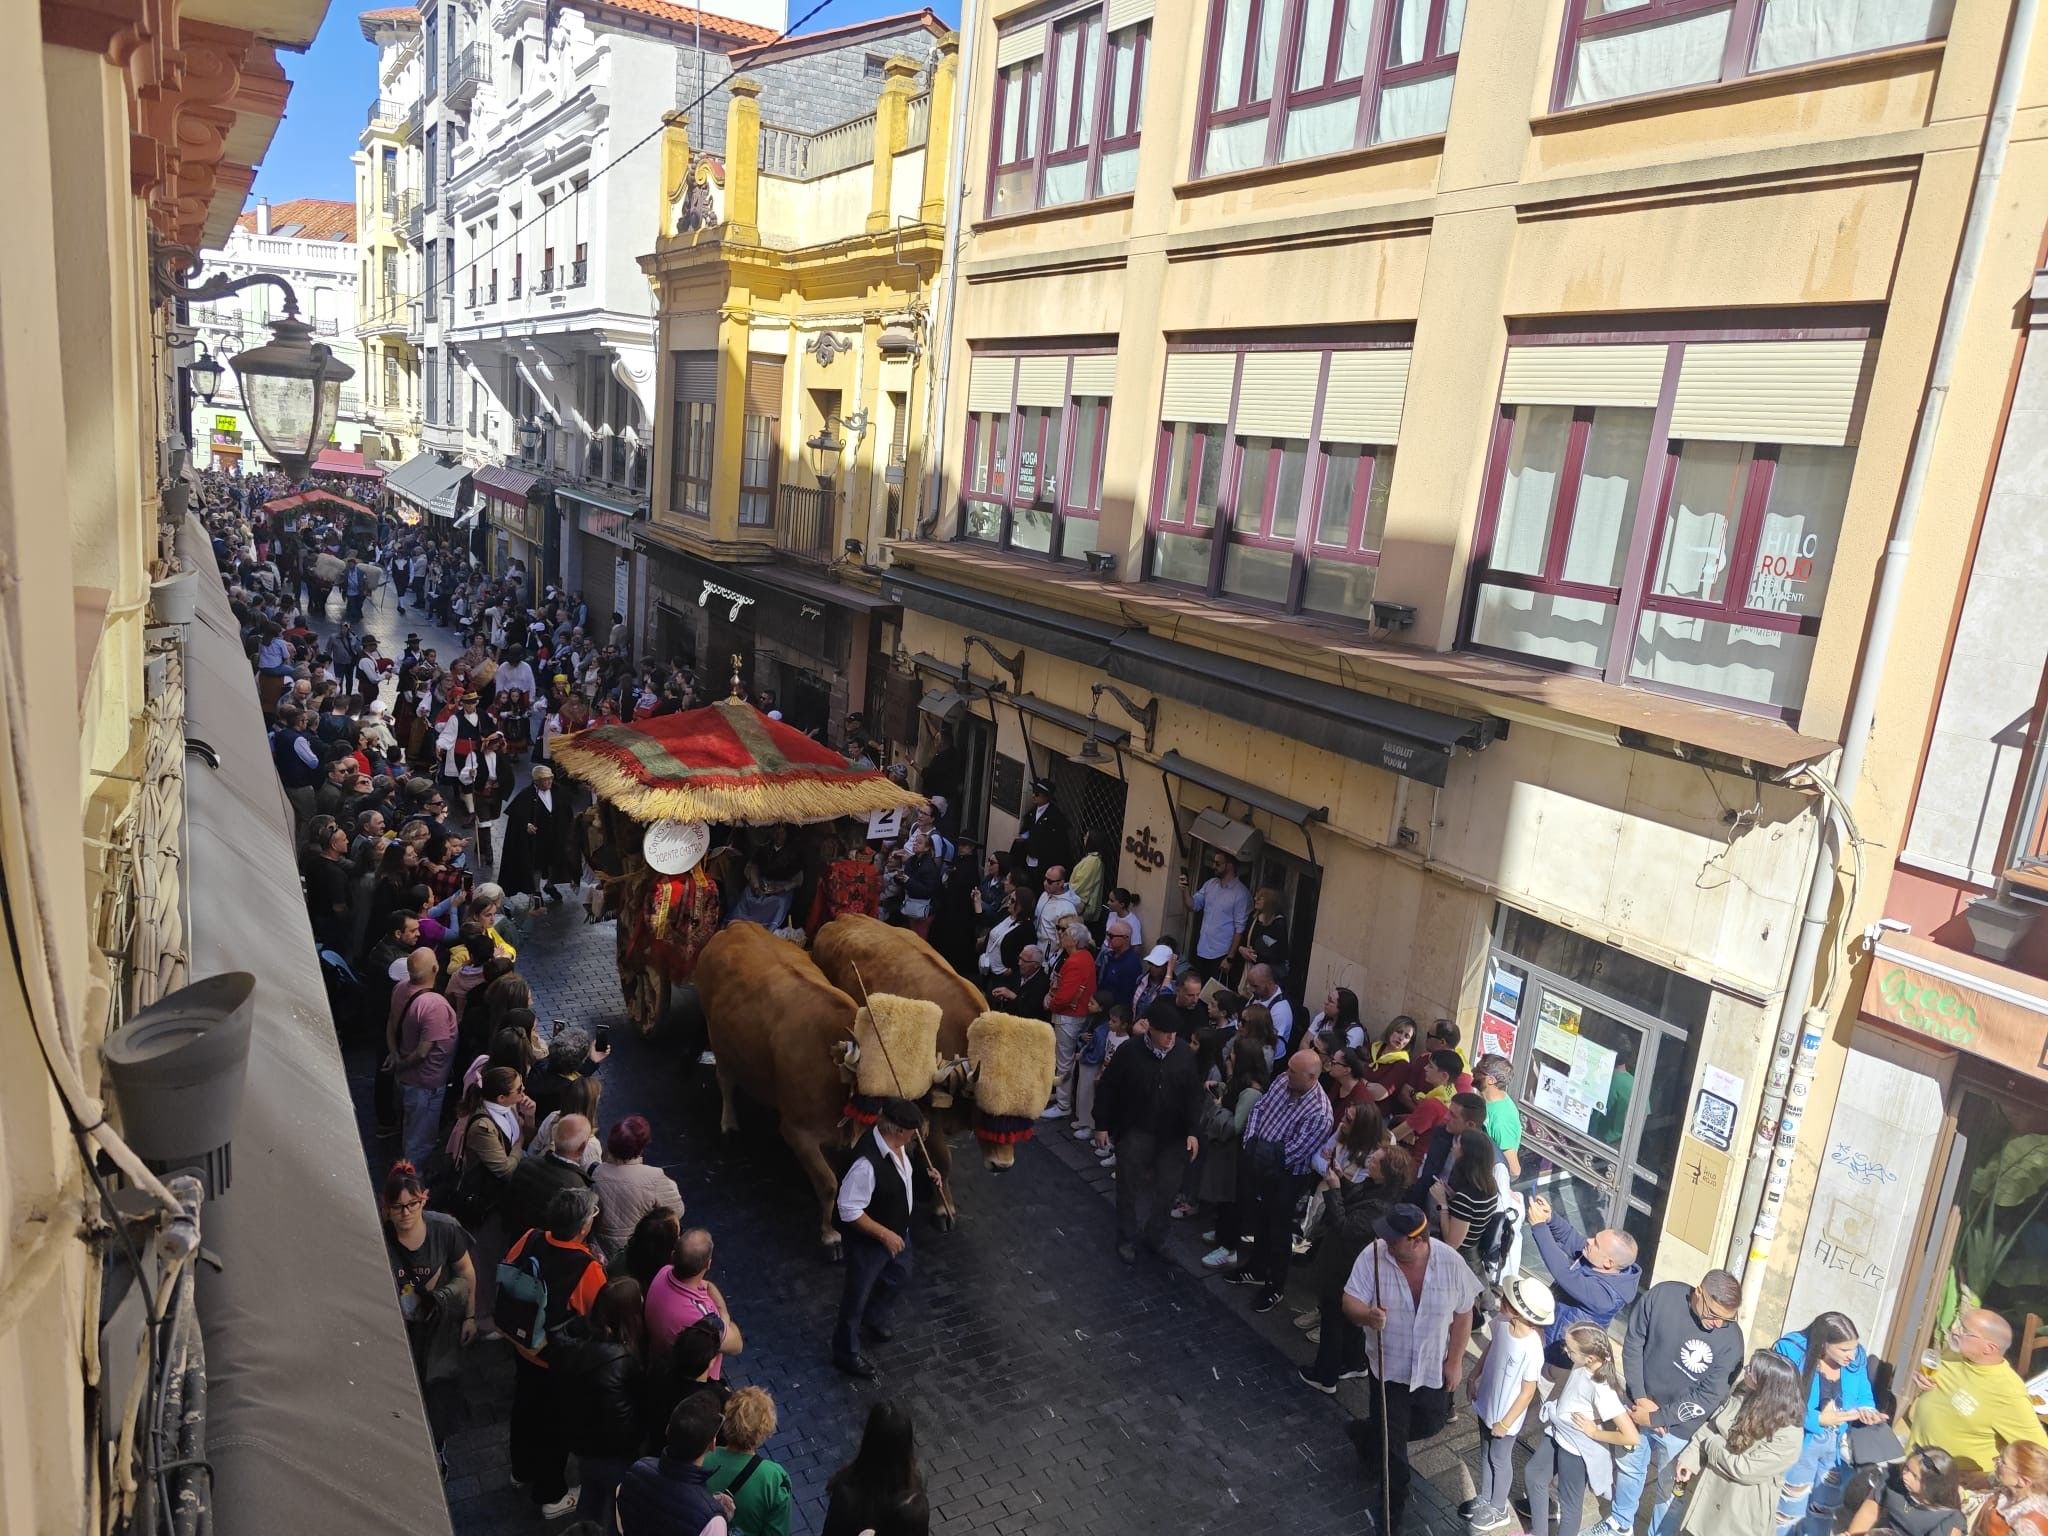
{"left": 1864, "top": 932, "right": 2048, "bottom": 1077}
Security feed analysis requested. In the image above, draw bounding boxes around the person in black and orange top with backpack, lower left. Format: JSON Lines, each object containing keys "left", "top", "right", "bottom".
{"left": 492, "top": 1184, "right": 606, "bottom": 1520}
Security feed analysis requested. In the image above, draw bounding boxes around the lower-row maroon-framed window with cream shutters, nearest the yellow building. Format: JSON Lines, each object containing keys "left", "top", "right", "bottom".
{"left": 961, "top": 352, "right": 1116, "bottom": 559}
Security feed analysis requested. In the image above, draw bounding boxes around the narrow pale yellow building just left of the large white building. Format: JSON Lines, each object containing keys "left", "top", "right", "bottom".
{"left": 354, "top": 6, "right": 434, "bottom": 465}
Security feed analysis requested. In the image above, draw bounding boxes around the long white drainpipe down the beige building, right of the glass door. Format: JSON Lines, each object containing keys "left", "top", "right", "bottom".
{"left": 1729, "top": 0, "right": 2040, "bottom": 1319}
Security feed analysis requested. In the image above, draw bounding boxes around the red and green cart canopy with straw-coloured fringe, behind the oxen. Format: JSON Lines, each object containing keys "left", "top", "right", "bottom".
{"left": 549, "top": 698, "right": 924, "bottom": 827}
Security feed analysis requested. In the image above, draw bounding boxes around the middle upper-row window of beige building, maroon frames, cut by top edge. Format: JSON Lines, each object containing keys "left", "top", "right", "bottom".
{"left": 1196, "top": 0, "right": 1466, "bottom": 176}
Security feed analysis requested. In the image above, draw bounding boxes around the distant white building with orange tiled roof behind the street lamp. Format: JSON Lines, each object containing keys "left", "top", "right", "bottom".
{"left": 190, "top": 197, "right": 369, "bottom": 471}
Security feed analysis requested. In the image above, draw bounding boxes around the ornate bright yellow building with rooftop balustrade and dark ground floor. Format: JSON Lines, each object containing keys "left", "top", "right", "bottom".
{"left": 635, "top": 24, "right": 956, "bottom": 733}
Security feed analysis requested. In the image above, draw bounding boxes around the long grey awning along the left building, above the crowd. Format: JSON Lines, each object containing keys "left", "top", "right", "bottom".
{"left": 178, "top": 518, "right": 449, "bottom": 1536}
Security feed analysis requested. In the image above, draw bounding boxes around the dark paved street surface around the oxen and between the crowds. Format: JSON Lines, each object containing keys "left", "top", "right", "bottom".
{"left": 348, "top": 589, "right": 1470, "bottom": 1536}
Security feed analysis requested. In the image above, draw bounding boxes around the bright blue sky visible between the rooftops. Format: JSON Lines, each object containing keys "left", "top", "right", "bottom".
{"left": 256, "top": 0, "right": 961, "bottom": 203}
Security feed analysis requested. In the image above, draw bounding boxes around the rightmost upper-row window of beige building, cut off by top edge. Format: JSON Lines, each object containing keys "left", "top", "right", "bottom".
{"left": 1550, "top": 0, "right": 1954, "bottom": 109}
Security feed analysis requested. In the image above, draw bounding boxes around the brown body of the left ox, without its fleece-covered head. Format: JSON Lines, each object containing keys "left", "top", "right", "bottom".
{"left": 692, "top": 922, "right": 950, "bottom": 1257}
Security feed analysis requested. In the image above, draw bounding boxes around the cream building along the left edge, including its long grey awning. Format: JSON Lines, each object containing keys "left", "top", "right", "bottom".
{"left": 0, "top": 0, "right": 444, "bottom": 1536}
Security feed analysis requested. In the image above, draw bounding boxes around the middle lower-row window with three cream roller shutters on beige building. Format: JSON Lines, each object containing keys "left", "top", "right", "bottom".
{"left": 1149, "top": 344, "right": 1409, "bottom": 621}
